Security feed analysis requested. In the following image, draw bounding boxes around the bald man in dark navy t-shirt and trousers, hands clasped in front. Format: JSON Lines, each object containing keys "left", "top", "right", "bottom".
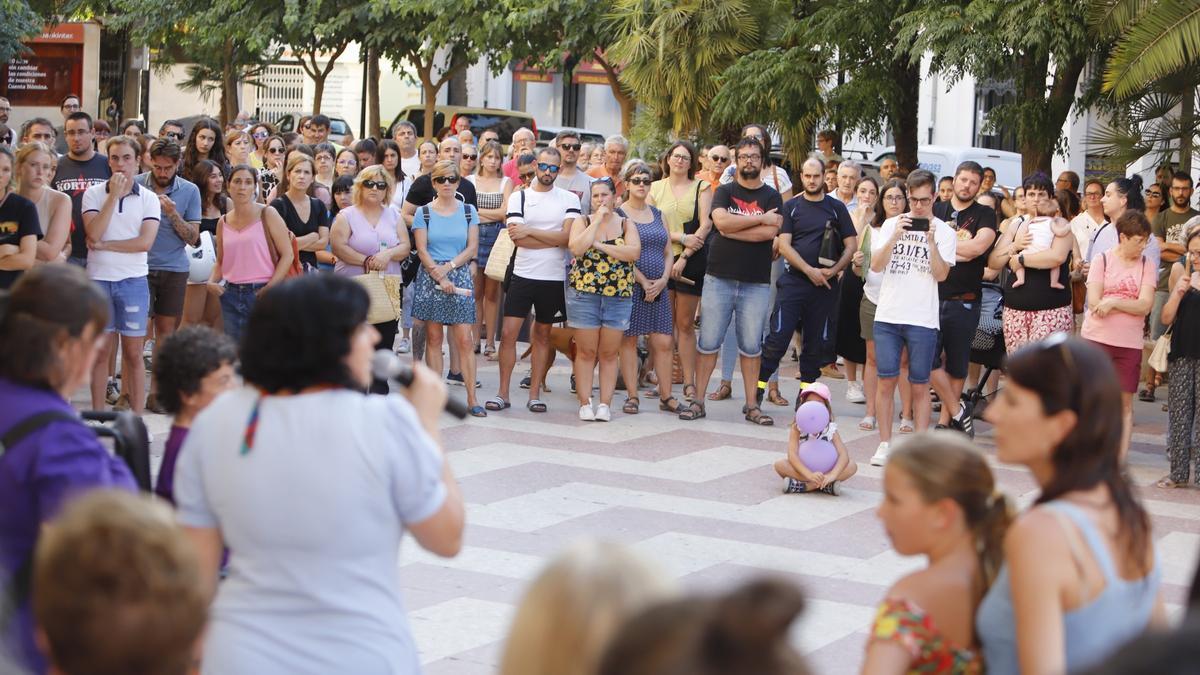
{"left": 757, "top": 157, "right": 858, "bottom": 393}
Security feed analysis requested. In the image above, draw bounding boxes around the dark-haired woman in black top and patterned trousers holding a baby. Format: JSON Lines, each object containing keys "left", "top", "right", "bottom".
{"left": 988, "top": 173, "right": 1075, "bottom": 353}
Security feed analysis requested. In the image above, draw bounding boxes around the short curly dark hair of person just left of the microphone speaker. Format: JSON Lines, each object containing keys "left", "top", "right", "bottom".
{"left": 154, "top": 325, "right": 238, "bottom": 414}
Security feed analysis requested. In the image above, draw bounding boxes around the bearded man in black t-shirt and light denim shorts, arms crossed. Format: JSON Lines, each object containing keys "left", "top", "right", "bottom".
{"left": 679, "top": 138, "right": 784, "bottom": 425}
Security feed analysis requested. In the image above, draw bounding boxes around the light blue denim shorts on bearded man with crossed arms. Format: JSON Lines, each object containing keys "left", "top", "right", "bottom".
{"left": 696, "top": 274, "right": 770, "bottom": 358}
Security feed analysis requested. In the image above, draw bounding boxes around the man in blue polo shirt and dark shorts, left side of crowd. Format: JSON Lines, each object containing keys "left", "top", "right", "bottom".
{"left": 136, "top": 138, "right": 200, "bottom": 413}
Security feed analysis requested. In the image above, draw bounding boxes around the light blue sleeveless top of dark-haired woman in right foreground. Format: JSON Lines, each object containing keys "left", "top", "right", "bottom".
{"left": 976, "top": 501, "right": 1163, "bottom": 675}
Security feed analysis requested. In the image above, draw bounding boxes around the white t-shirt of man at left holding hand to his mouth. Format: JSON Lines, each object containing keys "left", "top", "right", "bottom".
{"left": 80, "top": 181, "right": 162, "bottom": 281}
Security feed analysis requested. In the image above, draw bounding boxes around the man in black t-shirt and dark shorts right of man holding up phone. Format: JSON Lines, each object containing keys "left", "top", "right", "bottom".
{"left": 930, "top": 161, "right": 996, "bottom": 438}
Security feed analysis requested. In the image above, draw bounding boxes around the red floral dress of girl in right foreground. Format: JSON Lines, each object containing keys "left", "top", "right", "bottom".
{"left": 871, "top": 598, "right": 983, "bottom": 675}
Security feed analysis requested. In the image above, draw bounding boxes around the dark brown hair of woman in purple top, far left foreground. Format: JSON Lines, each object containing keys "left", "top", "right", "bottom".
{"left": 0, "top": 265, "right": 109, "bottom": 389}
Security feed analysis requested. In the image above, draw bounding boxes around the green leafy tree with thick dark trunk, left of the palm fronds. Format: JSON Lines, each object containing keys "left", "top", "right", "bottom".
{"left": 898, "top": 0, "right": 1103, "bottom": 173}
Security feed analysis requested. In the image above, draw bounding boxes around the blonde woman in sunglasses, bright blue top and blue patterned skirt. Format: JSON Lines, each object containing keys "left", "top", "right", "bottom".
{"left": 413, "top": 160, "right": 487, "bottom": 417}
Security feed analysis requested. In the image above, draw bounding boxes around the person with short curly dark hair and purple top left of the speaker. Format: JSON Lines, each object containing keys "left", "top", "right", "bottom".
{"left": 154, "top": 325, "right": 238, "bottom": 503}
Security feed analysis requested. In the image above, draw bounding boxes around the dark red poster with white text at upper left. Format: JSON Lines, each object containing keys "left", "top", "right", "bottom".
{"left": 0, "top": 24, "right": 83, "bottom": 108}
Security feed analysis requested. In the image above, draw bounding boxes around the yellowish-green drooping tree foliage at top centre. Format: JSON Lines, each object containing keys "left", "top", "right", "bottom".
{"left": 607, "top": 0, "right": 758, "bottom": 137}
